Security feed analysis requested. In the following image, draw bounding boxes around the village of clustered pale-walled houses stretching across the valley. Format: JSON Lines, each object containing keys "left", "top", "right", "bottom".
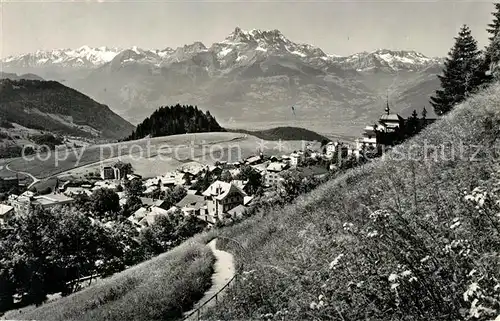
{"left": 0, "top": 103, "right": 434, "bottom": 231}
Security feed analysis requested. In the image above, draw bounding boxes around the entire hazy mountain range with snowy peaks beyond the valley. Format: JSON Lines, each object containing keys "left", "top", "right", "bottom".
{"left": 1, "top": 28, "right": 444, "bottom": 135}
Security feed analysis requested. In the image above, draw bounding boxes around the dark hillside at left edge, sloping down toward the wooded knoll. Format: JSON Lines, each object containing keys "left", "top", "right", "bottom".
{"left": 0, "top": 79, "right": 134, "bottom": 139}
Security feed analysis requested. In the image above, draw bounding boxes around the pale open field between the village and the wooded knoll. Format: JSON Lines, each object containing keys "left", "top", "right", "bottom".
{"left": 3, "top": 133, "right": 316, "bottom": 179}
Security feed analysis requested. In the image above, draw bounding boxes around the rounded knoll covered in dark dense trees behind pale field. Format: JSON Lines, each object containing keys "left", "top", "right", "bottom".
{"left": 126, "top": 104, "right": 225, "bottom": 140}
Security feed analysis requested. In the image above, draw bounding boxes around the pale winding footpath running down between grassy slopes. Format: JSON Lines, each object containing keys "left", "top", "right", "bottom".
{"left": 182, "top": 239, "right": 236, "bottom": 321}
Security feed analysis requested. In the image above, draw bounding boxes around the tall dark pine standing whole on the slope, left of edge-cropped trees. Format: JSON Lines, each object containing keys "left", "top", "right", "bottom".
{"left": 430, "top": 25, "right": 483, "bottom": 115}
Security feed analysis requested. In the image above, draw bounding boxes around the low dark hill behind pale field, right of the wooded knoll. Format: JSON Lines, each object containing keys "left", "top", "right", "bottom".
{"left": 230, "top": 127, "right": 328, "bottom": 142}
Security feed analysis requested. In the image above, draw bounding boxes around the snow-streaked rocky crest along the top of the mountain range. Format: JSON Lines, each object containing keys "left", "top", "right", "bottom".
{"left": 0, "top": 27, "right": 442, "bottom": 71}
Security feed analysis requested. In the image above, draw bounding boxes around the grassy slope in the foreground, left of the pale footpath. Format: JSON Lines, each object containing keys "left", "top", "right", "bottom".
{"left": 3, "top": 234, "right": 215, "bottom": 321}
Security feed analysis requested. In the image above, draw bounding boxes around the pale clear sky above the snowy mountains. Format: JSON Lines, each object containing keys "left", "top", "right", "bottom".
{"left": 0, "top": 0, "right": 493, "bottom": 57}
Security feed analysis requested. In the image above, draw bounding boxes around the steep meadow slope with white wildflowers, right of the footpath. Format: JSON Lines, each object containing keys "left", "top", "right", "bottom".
{"left": 202, "top": 85, "right": 500, "bottom": 320}
